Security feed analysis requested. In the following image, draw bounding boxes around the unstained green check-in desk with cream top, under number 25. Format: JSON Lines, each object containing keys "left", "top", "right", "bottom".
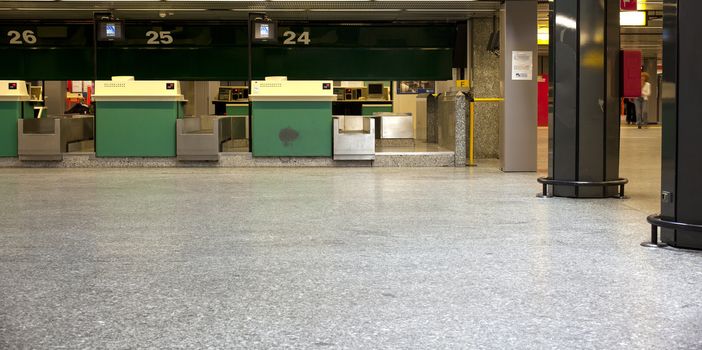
{"left": 93, "top": 77, "right": 185, "bottom": 157}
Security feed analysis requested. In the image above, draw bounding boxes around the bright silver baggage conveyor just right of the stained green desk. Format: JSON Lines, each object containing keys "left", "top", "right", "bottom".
{"left": 334, "top": 116, "right": 375, "bottom": 160}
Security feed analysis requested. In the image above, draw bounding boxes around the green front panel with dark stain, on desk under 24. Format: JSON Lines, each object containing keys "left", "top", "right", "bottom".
{"left": 252, "top": 101, "right": 332, "bottom": 157}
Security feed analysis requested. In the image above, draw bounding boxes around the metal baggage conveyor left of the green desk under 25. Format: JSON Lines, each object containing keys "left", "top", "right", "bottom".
{"left": 17, "top": 115, "right": 95, "bottom": 161}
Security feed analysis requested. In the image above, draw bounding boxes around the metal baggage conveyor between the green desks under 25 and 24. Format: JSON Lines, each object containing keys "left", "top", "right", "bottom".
{"left": 176, "top": 116, "right": 235, "bottom": 161}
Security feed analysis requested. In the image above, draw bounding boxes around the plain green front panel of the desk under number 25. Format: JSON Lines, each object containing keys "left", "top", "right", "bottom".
{"left": 95, "top": 101, "right": 180, "bottom": 157}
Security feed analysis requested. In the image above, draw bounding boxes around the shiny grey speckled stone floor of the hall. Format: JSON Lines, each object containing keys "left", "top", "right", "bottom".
{"left": 0, "top": 129, "right": 702, "bottom": 349}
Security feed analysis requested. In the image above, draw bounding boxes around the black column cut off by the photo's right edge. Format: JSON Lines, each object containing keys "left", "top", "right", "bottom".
{"left": 661, "top": 0, "right": 702, "bottom": 249}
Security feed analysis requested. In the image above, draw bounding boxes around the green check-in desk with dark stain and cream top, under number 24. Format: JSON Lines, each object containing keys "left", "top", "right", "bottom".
{"left": 249, "top": 77, "right": 336, "bottom": 157}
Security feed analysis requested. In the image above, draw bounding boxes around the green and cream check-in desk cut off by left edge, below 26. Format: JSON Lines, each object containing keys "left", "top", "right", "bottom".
{"left": 0, "top": 80, "right": 34, "bottom": 157}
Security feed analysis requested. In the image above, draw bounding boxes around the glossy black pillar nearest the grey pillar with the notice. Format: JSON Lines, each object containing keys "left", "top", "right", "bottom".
{"left": 548, "top": 0, "right": 620, "bottom": 198}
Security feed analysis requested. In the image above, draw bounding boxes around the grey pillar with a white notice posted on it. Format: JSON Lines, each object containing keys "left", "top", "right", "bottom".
{"left": 500, "top": 0, "right": 538, "bottom": 171}
